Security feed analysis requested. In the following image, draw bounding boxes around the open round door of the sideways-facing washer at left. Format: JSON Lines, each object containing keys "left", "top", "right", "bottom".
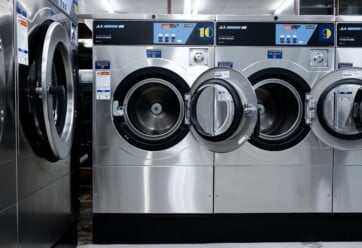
{"left": 20, "top": 21, "right": 75, "bottom": 161}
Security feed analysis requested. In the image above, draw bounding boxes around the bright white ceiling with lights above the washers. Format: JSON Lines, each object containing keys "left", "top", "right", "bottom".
{"left": 78, "top": 0, "right": 294, "bottom": 15}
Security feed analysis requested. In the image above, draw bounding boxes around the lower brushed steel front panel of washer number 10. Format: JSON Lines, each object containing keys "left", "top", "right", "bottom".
{"left": 93, "top": 166, "right": 213, "bottom": 213}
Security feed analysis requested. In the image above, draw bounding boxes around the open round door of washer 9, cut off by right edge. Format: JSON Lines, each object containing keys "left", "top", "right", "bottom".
{"left": 306, "top": 68, "right": 362, "bottom": 150}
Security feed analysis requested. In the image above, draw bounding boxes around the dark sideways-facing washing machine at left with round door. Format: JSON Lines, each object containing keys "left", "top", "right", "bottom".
{"left": 14, "top": 0, "right": 77, "bottom": 247}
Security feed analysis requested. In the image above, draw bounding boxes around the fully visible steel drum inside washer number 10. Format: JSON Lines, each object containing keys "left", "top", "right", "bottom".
{"left": 123, "top": 78, "right": 184, "bottom": 140}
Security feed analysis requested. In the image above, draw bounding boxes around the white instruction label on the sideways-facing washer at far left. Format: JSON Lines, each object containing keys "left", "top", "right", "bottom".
{"left": 17, "top": 15, "right": 29, "bottom": 65}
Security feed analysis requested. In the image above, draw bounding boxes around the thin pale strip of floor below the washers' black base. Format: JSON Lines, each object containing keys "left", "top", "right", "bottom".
{"left": 78, "top": 242, "right": 362, "bottom": 248}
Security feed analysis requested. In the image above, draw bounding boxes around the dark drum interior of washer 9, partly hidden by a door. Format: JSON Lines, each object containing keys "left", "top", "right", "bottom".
{"left": 254, "top": 78, "right": 303, "bottom": 141}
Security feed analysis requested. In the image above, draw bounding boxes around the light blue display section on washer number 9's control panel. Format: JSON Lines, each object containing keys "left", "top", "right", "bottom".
{"left": 275, "top": 24, "right": 318, "bottom": 46}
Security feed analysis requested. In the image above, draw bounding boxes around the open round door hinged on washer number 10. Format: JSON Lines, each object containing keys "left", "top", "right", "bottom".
{"left": 186, "top": 68, "right": 258, "bottom": 153}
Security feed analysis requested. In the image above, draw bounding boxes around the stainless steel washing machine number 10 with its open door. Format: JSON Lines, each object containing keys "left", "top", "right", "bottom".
{"left": 93, "top": 15, "right": 257, "bottom": 243}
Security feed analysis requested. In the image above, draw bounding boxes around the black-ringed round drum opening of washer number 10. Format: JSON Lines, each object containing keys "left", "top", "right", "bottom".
{"left": 111, "top": 67, "right": 190, "bottom": 151}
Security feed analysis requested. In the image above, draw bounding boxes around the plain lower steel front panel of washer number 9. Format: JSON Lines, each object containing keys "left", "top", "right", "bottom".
{"left": 215, "top": 164, "right": 332, "bottom": 213}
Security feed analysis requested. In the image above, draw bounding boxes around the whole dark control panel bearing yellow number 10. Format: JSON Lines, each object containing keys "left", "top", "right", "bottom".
{"left": 93, "top": 20, "right": 214, "bottom": 45}
